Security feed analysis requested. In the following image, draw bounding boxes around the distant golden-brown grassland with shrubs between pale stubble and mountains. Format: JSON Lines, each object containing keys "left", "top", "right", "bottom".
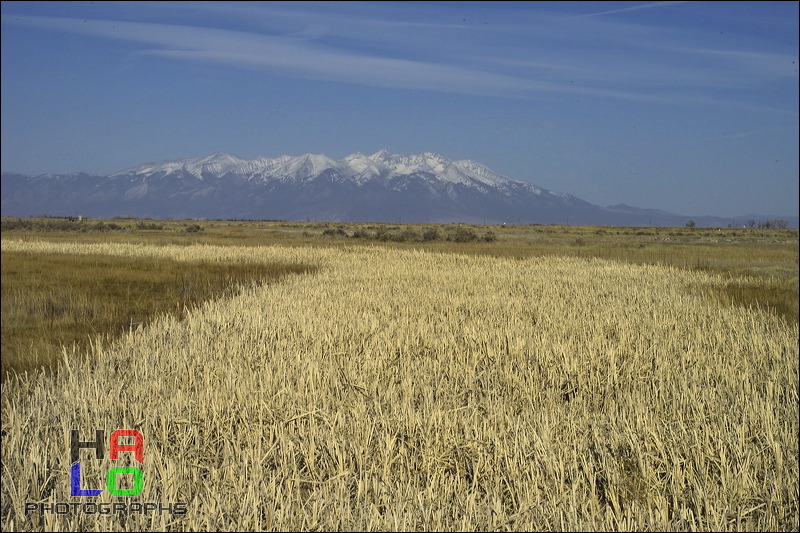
{"left": 2, "top": 218, "right": 798, "bottom": 322}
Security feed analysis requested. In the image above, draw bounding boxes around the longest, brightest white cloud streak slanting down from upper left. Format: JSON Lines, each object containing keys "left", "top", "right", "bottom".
{"left": 4, "top": 16, "right": 667, "bottom": 102}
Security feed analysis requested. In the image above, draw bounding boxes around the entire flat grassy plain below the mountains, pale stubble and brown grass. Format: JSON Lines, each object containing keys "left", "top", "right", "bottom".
{"left": 2, "top": 219, "right": 800, "bottom": 531}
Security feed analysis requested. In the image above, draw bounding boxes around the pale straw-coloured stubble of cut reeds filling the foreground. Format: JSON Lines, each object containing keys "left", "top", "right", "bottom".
{"left": 2, "top": 241, "right": 800, "bottom": 531}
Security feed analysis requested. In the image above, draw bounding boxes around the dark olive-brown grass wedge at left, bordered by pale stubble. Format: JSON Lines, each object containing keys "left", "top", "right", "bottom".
{"left": 2, "top": 251, "right": 316, "bottom": 379}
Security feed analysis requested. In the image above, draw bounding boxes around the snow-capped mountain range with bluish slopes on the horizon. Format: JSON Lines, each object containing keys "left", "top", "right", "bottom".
{"left": 2, "top": 150, "right": 788, "bottom": 225}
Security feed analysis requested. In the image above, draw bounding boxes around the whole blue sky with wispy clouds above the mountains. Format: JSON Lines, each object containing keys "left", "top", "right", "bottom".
{"left": 0, "top": 2, "right": 800, "bottom": 216}
